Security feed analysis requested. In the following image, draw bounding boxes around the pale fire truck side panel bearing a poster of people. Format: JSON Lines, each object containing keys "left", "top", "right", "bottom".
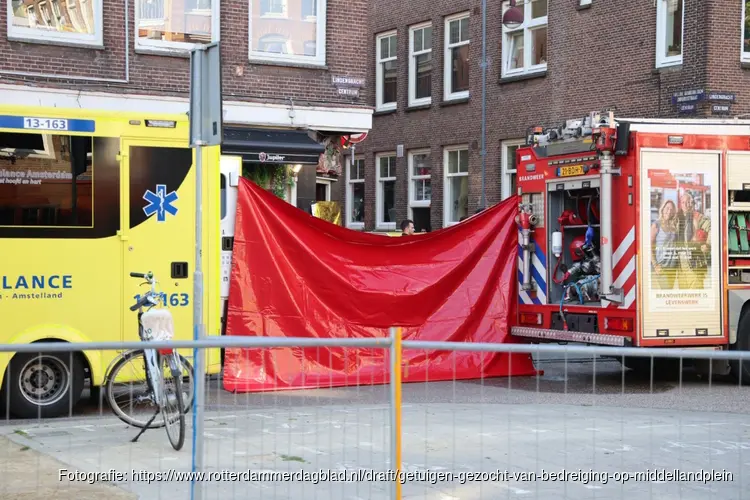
{"left": 641, "top": 151, "right": 721, "bottom": 337}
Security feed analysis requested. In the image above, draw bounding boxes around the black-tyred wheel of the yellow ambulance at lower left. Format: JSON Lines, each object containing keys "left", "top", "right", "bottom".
{"left": 3, "top": 352, "right": 86, "bottom": 418}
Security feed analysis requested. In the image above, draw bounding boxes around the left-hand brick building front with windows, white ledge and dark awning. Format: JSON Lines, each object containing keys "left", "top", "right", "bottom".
{"left": 0, "top": 0, "right": 372, "bottom": 213}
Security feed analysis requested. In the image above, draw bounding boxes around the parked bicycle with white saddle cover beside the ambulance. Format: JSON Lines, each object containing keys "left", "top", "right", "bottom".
{"left": 105, "top": 272, "right": 194, "bottom": 450}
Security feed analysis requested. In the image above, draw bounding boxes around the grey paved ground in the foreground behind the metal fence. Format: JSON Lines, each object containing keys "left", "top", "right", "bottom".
{"left": 0, "top": 360, "right": 750, "bottom": 500}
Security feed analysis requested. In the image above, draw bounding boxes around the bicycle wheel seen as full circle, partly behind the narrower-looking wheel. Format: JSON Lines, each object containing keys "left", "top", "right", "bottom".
{"left": 104, "top": 351, "right": 195, "bottom": 429}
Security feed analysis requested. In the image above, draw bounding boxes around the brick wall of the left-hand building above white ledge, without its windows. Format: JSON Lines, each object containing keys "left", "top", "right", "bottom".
{"left": 0, "top": 0, "right": 369, "bottom": 106}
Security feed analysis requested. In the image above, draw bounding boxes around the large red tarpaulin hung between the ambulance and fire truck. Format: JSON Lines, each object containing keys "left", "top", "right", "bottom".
{"left": 223, "top": 179, "right": 536, "bottom": 392}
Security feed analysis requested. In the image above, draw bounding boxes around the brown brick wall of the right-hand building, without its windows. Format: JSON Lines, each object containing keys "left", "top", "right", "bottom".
{"left": 340, "top": 0, "right": 750, "bottom": 230}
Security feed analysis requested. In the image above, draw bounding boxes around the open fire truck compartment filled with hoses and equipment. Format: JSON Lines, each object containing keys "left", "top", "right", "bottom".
{"left": 546, "top": 177, "right": 601, "bottom": 306}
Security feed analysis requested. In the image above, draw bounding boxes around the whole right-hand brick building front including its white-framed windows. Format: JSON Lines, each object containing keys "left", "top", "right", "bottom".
{"left": 340, "top": 0, "right": 750, "bottom": 231}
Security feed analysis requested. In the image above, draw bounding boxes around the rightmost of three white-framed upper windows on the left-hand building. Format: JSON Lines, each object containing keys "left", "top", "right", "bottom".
{"left": 248, "top": 0, "right": 326, "bottom": 66}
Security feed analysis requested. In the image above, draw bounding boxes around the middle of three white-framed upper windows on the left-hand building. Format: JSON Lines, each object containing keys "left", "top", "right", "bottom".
{"left": 135, "top": 0, "right": 219, "bottom": 51}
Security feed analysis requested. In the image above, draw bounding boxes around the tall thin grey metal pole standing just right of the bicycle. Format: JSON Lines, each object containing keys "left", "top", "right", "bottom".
{"left": 190, "top": 50, "right": 206, "bottom": 500}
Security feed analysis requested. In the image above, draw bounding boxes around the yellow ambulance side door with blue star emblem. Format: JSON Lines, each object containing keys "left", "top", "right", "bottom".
{"left": 122, "top": 141, "right": 195, "bottom": 346}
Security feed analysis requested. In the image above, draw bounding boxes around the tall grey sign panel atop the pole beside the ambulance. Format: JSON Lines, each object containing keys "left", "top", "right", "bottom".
{"left": 190, "top": 42, "right": 223, "bottom": 147}
